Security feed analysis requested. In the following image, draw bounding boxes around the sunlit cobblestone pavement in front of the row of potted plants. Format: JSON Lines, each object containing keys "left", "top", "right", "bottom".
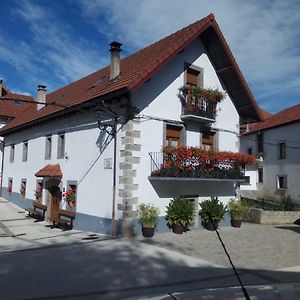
{"left": 141, "top": 223, "right": 300, "bottom": 270}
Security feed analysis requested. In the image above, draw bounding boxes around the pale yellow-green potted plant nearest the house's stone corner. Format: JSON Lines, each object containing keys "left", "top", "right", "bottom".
{"left": 137, "top": 203, "right": 159, "bottom": 237}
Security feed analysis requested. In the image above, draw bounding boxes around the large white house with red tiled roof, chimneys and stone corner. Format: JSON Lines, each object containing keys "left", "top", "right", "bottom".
{"left": 0, "top": 15, "right": 262, "bottom": 233}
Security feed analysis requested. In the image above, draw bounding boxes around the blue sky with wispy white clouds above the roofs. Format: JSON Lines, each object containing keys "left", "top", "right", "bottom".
{"left": 0, "top": 0, "right": 300, "bottom": 113}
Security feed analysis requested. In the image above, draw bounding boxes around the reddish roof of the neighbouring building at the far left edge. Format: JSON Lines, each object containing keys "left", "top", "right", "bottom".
{"left": 0, "top": 86, "right": 34, "bottom": 118}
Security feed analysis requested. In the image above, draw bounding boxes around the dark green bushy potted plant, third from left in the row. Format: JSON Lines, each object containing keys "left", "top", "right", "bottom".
{"left": 199, "top": 197, "right": 226, "bottom": 231}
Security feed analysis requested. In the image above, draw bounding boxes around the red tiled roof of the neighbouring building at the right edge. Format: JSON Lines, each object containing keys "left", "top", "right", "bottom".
{"left": 245, "top": 104, "right": 300, "bottom": 135}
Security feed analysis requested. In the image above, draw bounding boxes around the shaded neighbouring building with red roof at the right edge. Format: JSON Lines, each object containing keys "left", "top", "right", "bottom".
{"left": 241, "top": 105, "right": 300, "bottom": 204}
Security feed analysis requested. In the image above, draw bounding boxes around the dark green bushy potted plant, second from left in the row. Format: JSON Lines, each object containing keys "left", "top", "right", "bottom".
{"left": 166, "top": 196, "right": 195, "bottom": 234}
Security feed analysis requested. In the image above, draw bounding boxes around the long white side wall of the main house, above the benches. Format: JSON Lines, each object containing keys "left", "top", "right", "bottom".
{"left": 3, "top": 113, "right": 113, "bottom": 218}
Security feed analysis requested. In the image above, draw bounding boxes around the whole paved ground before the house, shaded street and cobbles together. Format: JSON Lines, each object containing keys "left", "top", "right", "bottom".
{"left": 0, "top": 200, "right": 300, "bottom": 300}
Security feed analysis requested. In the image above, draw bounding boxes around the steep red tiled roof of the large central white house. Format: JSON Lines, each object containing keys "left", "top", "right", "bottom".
{"left": 0, "top": 14, "right": 263, "bottom": 135}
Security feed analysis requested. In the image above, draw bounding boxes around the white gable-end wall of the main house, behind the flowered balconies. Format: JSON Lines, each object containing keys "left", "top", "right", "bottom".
{"left": 132, "top": 40, "right": 239, "bottom": 214}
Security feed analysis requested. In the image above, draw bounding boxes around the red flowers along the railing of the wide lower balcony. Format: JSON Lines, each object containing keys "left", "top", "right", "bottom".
{"left": 150, "top": 146, "right": 255, "bottom": 179}
